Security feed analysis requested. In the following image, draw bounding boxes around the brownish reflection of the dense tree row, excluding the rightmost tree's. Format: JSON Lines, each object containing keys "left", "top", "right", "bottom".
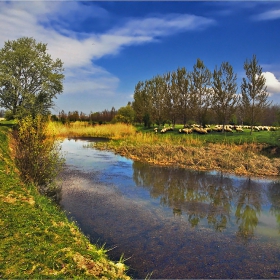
{"left": 133, "top": 162, "right": 233, "bottom": 231}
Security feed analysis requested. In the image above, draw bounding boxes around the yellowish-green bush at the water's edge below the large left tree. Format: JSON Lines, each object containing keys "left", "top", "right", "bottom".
{"left": 11, "top": 115, "right": 64, "bottom": 199}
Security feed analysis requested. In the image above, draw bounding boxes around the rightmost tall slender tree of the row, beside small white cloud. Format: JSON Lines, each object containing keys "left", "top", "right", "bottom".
{"left": 241, "top": 55, "right": 271, "bottom": 134}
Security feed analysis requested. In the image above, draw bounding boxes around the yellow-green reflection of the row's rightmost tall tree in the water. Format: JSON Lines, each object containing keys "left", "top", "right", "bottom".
{"left": 235, "top": 179, "right": 262, "bottom": 242}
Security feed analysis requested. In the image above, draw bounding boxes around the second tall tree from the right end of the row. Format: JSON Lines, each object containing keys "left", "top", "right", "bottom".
{"left": 211, "top": 62, "right": 238, "bottom": 131}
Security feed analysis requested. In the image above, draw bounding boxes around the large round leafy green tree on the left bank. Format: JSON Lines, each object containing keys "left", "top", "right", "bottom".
{"left": 0, "top": 37, "right": 64, "bottom": 118}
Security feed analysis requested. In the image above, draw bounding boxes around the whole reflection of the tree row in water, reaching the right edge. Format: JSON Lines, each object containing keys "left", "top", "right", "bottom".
{"left": 133, "top": 162, "right": 280, "bottom": 242}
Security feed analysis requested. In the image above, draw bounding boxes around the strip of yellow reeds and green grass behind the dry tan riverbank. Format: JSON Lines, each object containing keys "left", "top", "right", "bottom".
{"left": 49, "top": 122, "right": 280, "bottom": 147}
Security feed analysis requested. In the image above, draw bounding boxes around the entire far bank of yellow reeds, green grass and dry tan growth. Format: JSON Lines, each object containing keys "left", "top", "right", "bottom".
{"left": 49, "top": 123, "right": 280, "bottom": 177}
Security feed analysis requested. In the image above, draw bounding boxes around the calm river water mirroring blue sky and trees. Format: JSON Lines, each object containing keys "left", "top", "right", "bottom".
{"left": 60, "top": 139, "right": 280, "bottom": 279}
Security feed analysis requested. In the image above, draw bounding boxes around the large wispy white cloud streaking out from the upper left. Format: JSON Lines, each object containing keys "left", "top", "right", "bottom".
{"left": 0, "top": 1, "right": 215, "bottom": 112}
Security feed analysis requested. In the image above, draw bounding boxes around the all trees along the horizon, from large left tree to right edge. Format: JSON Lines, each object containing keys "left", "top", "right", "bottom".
{"left": 0, "top": 37, "right": 279, "bottom": 135}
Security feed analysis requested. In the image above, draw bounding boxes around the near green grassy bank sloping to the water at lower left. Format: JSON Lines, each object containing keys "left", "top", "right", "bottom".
{"left": 0, "top": 126, "right": 129, "bottom": 279}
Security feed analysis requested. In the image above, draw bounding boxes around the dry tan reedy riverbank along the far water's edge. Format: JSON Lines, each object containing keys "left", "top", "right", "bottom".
{"left": 96, "top": 139, "right": 280, "bottom": 177}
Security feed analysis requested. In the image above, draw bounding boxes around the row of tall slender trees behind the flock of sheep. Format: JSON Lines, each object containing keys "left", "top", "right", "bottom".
{"left": 132, "top": 55, "right": 270, "bottom": 133}
